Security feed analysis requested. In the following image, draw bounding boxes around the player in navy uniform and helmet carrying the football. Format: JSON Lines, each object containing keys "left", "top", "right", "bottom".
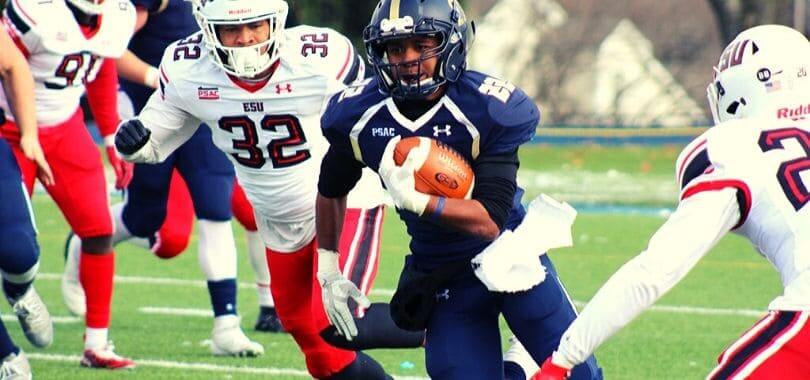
{"left": 317, "top": 0, "right": 601, "bottom": 379}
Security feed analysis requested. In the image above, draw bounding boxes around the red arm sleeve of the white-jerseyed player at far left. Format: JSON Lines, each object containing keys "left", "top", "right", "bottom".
{"left": 86, "top": 58, "right": 119, "bottom": 137}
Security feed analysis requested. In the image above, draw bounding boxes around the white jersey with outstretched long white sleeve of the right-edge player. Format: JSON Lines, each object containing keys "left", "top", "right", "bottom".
{"left": 554, "top": 118, "right": 810, "bottom": 368}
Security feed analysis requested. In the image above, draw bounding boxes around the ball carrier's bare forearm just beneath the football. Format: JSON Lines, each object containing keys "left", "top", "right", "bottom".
{"left": 422, "top": 196, "right": 501, "bottom": 240}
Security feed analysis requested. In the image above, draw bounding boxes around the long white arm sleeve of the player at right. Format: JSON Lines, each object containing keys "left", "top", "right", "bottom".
{"left": 553, "top": 188, "right": 740, "bottom": 368}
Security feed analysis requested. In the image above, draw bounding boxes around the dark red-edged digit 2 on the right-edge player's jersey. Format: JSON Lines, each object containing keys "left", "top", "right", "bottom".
{"left": 759, "top": 128, "right": 810, "bottom": 211}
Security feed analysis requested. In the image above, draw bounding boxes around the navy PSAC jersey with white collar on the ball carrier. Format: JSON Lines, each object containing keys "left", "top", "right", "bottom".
{"left": 321, "top": 71, "right": 540, "bottom": 268}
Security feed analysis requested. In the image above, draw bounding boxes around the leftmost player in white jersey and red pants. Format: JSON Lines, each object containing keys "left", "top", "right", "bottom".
{"left": 0, "top": 0, "right": 135, "bottom": 369}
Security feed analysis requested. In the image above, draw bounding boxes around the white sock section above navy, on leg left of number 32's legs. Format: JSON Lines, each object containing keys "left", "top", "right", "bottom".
{"left": 197, "top": 219, "right": 236, "bottom": 281}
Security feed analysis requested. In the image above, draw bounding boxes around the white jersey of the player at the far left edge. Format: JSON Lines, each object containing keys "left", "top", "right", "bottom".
{"left": 0, "top": 0, "right": 135, "bottom": 128}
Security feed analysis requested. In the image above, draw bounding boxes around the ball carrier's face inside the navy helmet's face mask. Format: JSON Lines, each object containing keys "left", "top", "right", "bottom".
{"left": 385, "top": 36, "right": 439, "bottom": 88}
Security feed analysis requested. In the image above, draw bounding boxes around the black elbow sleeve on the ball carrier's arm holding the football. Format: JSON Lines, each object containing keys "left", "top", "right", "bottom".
{"left": 472, "top": 149, "right": 519, "bottom": 230}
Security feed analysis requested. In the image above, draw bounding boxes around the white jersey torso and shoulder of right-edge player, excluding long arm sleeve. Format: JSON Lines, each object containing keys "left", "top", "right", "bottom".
{"left": 678, "top": 119, "right": 810, "bottom": 310}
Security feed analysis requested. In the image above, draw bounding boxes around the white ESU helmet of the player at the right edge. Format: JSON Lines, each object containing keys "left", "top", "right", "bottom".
{"left": 706, "top": 25, "right": 810, "bottom": 124}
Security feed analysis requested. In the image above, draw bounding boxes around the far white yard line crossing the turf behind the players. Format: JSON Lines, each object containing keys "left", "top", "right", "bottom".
{"left": 37, "top": 273, "right": 766, "bottom": 317}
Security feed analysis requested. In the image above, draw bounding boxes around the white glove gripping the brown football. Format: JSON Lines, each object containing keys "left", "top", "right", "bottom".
{"left": 378, "top": 136, "right": 430, "bottom": 216}
